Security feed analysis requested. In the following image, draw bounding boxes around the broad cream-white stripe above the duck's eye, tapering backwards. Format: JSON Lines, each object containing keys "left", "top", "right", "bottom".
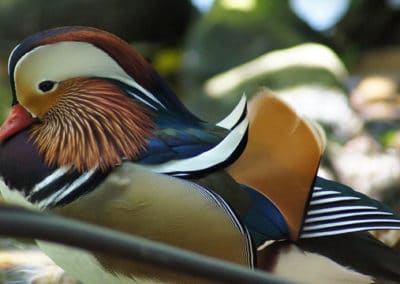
{"left": 13, "top": 41, "right": 166, "bottom": 108}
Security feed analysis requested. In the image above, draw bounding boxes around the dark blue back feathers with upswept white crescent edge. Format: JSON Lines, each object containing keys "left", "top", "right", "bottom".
{"left": 122, "top": 82, "right": 248, "bottom": 173}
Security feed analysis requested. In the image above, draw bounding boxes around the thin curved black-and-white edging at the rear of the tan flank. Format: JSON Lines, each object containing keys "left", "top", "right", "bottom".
{"left": 193, "top": 183, "right": 255, "bottom": 268}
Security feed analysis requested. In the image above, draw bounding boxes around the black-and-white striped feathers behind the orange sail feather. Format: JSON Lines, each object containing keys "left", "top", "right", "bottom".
{"left": 300, "top": 183, "right": 400, "bottom": 238}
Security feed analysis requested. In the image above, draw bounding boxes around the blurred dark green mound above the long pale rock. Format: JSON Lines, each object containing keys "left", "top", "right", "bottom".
{"left": 182, "top": 0, "right": 324, "bottom": 83}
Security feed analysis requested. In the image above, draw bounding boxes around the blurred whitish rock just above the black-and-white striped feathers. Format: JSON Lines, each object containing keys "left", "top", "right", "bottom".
{"left": 328, "top": 135, "right": 400, "bottom": 203}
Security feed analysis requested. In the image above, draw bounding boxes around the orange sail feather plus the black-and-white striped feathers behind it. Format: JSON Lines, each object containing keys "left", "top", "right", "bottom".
{"left": 228, "top": 94, "right": 400, "bottom": 244}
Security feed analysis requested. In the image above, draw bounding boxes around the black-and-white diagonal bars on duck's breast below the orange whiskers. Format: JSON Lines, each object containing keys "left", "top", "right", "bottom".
{"left": 27, "top": 168, "right": 107, "bottom": 209}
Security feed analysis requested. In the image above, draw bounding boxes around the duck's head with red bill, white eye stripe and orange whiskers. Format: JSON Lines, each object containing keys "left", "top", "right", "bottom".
{"left": 0, "top": 27, "right": 195, "bottom": 172}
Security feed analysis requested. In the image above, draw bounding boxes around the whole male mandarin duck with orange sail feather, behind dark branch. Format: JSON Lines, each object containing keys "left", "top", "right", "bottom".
{"left": 0, "top": 27, "right": 400, "bottom": 283}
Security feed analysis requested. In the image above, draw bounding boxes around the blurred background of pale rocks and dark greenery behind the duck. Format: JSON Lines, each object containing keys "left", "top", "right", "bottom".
{"left": 0, "top": 0, "right": 400, "bottom": 283}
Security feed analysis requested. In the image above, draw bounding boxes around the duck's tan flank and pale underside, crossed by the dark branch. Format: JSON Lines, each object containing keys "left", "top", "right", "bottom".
{"left": 0, "top": 164, "right": 253, "bottom": 284}
